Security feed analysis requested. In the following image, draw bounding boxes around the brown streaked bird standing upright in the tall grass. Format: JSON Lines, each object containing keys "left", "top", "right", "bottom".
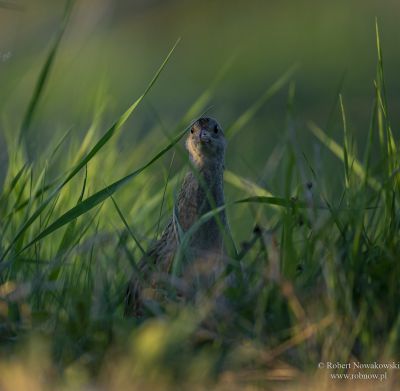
{"left": 124, "top": 117, "right": 228, "bottom": 318}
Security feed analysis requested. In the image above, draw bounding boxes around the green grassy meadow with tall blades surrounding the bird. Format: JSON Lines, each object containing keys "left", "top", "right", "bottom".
{"left": 0, "top": 2, "right": 400, "bottom": 390}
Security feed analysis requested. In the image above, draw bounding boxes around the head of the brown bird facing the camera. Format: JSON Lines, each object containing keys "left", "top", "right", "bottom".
{"left": 186, "top": 117, "right": 226, "bottom": 165}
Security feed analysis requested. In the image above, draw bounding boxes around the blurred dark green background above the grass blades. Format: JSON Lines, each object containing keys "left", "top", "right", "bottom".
{"left": 0, "top": 0, "right": 400, "bottom": 236}
